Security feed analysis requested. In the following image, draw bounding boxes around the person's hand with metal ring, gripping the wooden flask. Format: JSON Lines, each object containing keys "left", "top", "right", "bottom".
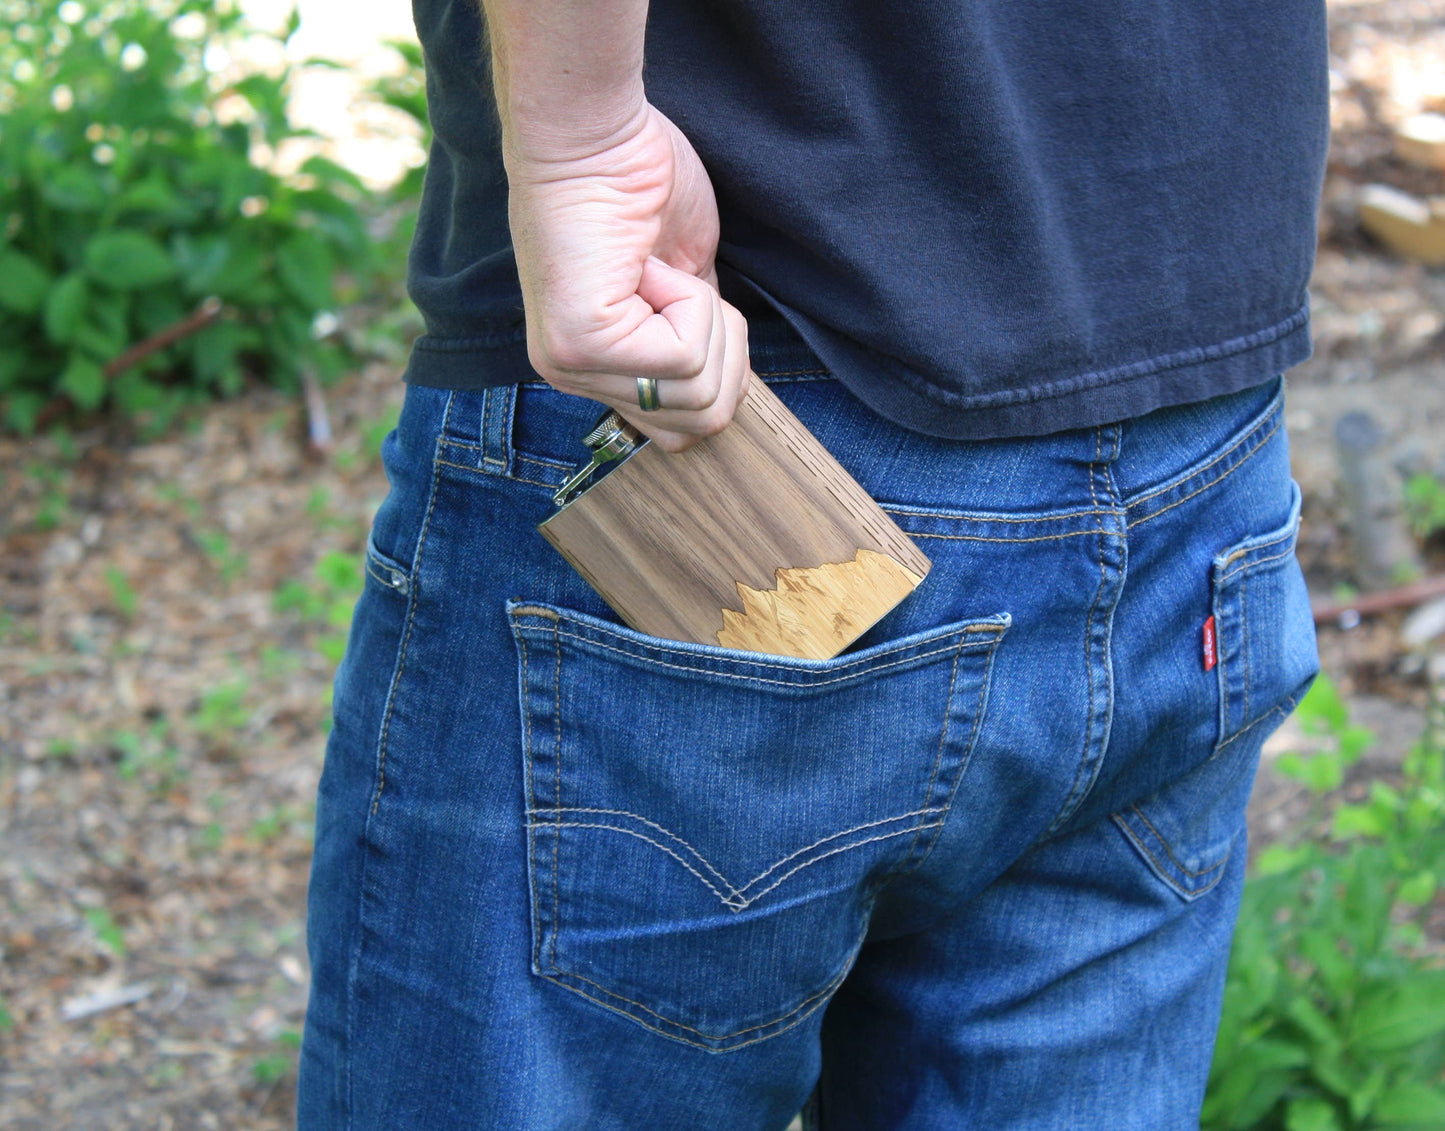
{"left": 506, "top": 103, "right": 749, "bottom": 452}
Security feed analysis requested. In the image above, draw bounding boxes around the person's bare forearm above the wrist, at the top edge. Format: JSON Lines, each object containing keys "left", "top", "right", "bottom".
{"left": 481, "top": 0, "right": 647, "bottom": 160}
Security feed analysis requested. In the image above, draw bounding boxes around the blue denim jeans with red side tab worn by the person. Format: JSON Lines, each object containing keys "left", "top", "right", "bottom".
{"left": 299, "top": 323, "right": 1316, "bottom": 1131}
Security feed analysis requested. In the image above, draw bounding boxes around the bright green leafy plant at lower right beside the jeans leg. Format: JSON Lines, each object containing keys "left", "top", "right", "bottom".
{"left": 1204, "top": 677, "right": 1445, "bottom": 1131}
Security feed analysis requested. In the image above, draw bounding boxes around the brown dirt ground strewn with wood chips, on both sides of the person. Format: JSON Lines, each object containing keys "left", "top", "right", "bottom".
{"left": 0, "top": 0, "right": 1445, "bottom": 1131}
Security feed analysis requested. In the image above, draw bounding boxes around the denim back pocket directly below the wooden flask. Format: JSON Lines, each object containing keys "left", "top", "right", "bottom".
{"left": 507, "top": 601, "right": 1009, "bottom": 1052}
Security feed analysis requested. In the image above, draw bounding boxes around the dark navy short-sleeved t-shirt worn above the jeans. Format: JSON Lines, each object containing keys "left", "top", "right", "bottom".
{"left": 406, "top": 0, "right": 1328, "bottom": 439}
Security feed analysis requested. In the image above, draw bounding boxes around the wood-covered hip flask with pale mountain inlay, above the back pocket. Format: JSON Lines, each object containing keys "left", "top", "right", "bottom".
{"left": 538, "top": 376, "right": 929, "bottom": 660}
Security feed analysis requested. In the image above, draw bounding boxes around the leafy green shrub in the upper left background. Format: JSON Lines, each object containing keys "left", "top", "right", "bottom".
{"left": 0, "top": 0, "right": 370, "bottom": 430}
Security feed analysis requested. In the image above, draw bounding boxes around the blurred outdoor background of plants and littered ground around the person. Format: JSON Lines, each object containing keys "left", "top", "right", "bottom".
{"left": 0, "top": 0, "right": 1445, "bottom": 1131}
